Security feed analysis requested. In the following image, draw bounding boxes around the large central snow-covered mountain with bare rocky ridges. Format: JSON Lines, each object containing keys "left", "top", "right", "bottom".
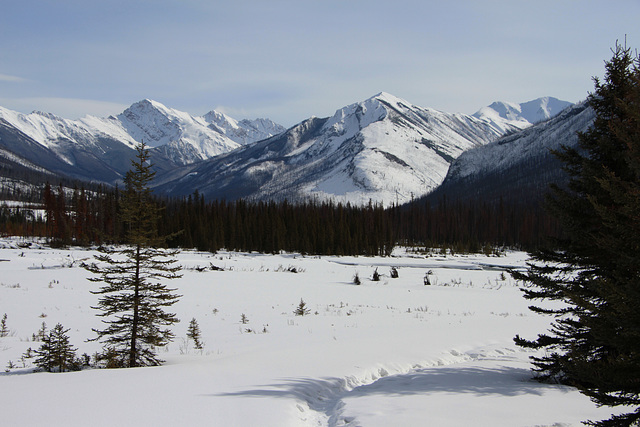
{"left": 155, "top": 93, "right": 540, "bottom": 204}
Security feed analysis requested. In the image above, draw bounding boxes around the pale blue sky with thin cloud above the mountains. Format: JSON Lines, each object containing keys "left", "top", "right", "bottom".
{"left": 0, "top": 0, "right": 640, "bottom": 126}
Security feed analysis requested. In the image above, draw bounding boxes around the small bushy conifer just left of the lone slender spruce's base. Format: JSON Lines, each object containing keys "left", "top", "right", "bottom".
{"left": 34, "top": 323, "right": 79, "bottom": 372}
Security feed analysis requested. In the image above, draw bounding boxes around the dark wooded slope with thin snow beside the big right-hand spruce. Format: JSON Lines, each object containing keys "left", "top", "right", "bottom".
{"left": 436, "top": 102, "right": 595, "bottom": 206}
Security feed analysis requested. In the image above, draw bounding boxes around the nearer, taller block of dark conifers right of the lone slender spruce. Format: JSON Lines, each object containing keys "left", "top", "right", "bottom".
{"left": 161, "top": 193, "right": 394, "bottom": 255}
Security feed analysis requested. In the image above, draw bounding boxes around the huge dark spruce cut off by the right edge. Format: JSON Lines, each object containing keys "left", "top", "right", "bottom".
{"left": 514, "top": 41, "right": 640, "bottom": 426}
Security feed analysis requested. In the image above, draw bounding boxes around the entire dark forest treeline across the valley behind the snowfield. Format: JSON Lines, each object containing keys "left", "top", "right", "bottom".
{"left": 0, "top": 184, "right": 560, "bottom": 255}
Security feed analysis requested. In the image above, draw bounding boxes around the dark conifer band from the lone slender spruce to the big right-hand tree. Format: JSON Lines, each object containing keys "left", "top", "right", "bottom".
{"left": 162, "top": 192, "right": 559, "bottom": 255}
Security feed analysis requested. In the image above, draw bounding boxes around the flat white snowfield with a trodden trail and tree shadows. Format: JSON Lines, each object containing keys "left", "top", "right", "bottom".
{"left": 0, "top": 241, "right": 610, "bottom": 426}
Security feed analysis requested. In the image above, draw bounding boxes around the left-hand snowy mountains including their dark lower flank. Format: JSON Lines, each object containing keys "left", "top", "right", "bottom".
{"left": 0, "top": 103, "right": 283, "bottom": 183}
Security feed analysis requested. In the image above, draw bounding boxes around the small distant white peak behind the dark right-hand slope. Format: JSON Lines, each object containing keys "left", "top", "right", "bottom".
{"left": 473, "top": 96, "right": 572, "bottom": 132}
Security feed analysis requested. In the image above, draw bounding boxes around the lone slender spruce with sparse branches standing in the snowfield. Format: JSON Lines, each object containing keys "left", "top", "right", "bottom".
{"left": 85, "top": 144, "right": 180, "bottom": 367}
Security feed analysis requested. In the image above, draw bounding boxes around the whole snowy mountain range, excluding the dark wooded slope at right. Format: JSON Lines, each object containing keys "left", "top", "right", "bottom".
{"left": 0, "top": 93, "right": 571, "bottom": 204}
